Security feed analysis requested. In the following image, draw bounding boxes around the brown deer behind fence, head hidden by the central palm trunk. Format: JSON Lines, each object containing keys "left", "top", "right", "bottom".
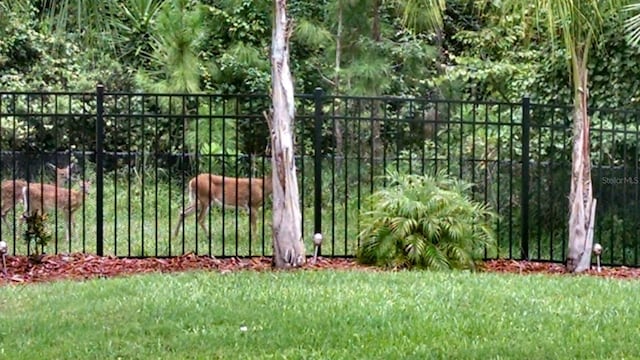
{"left": 173, "top": 173, "right": 273, "bottom": 243}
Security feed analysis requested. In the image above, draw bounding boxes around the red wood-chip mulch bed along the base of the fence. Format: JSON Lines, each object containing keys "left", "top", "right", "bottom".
{"left": 0, "top": 254, "right": 640, "bottom": 286}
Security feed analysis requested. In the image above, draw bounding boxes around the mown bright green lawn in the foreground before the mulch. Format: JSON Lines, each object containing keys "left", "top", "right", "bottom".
{"left": 0, "top": 271, "right": 640, "bottom": 359}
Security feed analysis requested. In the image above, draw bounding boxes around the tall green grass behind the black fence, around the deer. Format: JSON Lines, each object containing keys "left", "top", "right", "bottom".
{"left": 1, "top": 157, "right": 596, "bottom": 261}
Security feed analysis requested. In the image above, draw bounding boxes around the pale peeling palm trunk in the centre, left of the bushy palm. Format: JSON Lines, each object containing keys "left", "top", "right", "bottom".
{"left": 269, "top": 0, "right": 306, "bottom": 268}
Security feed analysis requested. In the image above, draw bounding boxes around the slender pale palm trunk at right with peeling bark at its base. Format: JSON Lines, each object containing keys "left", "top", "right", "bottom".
{"left": 567, "top": 59, "right": 596, "bottom": 272}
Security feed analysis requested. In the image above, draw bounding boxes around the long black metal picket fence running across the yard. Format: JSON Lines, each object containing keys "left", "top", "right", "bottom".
{"left": 0, "top": 86, "right": 640, "bottom": 265}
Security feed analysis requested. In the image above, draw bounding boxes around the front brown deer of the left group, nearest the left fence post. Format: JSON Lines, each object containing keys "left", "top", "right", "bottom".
{"left": 22, "top": 181, "right": 91, "bottom": 242}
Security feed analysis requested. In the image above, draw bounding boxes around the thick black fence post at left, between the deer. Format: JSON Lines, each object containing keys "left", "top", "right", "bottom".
{"left": 96, "top": 84, "right": 104, "bottom": 256}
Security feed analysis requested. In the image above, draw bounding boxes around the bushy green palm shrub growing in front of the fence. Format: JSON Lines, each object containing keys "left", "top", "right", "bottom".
{"left": 356, "top": 172, "right": 497, "bottom": 270}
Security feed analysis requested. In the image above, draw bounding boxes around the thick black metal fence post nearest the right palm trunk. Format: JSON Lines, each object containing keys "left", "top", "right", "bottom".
{"left": 520, "top": 96, "right": 531, "bottom": 260}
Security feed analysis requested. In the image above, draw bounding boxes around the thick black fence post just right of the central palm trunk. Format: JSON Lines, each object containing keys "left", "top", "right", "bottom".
{"left": 313, "top": 88, "right": 324, "bottom": 255}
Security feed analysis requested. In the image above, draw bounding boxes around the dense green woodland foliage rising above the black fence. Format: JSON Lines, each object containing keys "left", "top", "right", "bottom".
{"left": 0, "top": 0, "right": 640, "bottom": 153}
